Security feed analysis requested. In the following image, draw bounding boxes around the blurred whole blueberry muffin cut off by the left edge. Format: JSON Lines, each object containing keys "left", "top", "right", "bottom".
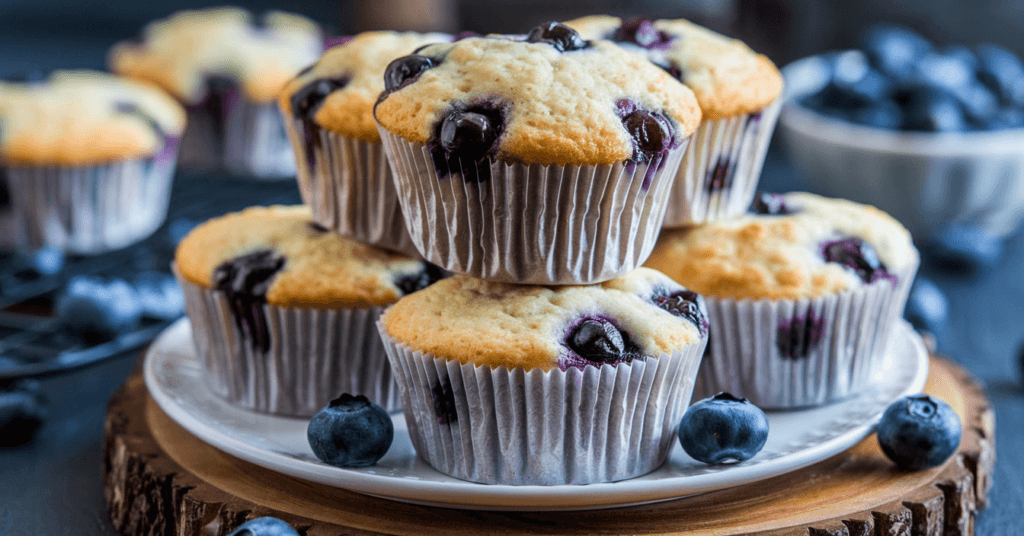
{"left": 0, "top": 71, "right": 185, "bottom": 254}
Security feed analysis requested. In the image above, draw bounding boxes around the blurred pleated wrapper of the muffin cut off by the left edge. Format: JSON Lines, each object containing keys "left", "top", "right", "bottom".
{"left": 6, "top": 148, "right": 177, "bottom": 254}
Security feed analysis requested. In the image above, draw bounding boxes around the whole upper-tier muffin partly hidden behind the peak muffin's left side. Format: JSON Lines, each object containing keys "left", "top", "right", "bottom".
{"left": 280, "top": 32, "right": 452, "bottom": 255}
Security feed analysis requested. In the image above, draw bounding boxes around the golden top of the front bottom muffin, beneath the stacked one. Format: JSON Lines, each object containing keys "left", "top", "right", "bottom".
{"left": 381, "top": 269, "right": 707, "bottom": 370}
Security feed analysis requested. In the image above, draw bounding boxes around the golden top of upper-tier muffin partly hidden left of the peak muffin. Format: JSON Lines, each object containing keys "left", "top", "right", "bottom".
{"left": 280, "top": 32, "right": 452, "bottom": 141}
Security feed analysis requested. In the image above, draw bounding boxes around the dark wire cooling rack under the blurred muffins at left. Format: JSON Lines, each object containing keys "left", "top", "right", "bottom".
{"left": 0, "top": 172, "right": 301, "bottom": 381}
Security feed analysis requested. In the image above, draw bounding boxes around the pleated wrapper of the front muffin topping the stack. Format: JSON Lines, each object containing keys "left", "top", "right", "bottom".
{"left": 378, "top": 125, "right": 687, "bottom": 285}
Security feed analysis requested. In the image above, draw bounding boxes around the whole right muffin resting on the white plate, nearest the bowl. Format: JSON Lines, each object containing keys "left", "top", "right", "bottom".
{"left": 647, "top": 193, "right": 920, "bottom": 408}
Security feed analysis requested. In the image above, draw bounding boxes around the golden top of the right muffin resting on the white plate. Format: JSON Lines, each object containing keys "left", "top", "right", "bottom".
{"left": 644, "top": 193, "right": 919, "bottom": 299}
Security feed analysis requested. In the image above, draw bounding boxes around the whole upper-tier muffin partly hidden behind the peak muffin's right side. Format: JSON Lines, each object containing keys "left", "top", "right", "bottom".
{"left": 565, "top": 15, "right": 782, "bottom": 226}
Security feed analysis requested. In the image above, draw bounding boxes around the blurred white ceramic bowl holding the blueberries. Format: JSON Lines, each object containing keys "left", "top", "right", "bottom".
{"left": 779, "top": 56, "right": 1024, "bottom": 238}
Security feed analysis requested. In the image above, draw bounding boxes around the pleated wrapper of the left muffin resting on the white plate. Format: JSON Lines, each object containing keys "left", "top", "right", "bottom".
{"left": 175, "top": 271, "right": 401, "bottom": 417}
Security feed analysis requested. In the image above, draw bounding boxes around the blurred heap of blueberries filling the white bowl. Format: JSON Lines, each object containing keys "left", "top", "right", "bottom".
{"left": 801, "top": 25, "right": 1024, "bottom": 132}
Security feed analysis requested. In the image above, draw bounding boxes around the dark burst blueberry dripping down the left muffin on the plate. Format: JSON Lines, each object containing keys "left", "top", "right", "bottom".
{"left": 213, "top": 249, "right": 285, "bottom": 353}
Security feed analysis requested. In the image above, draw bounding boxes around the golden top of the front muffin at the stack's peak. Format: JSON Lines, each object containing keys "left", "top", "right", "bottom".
{"left": 374, "top": 29, "right": 700, "bottom": 165}
